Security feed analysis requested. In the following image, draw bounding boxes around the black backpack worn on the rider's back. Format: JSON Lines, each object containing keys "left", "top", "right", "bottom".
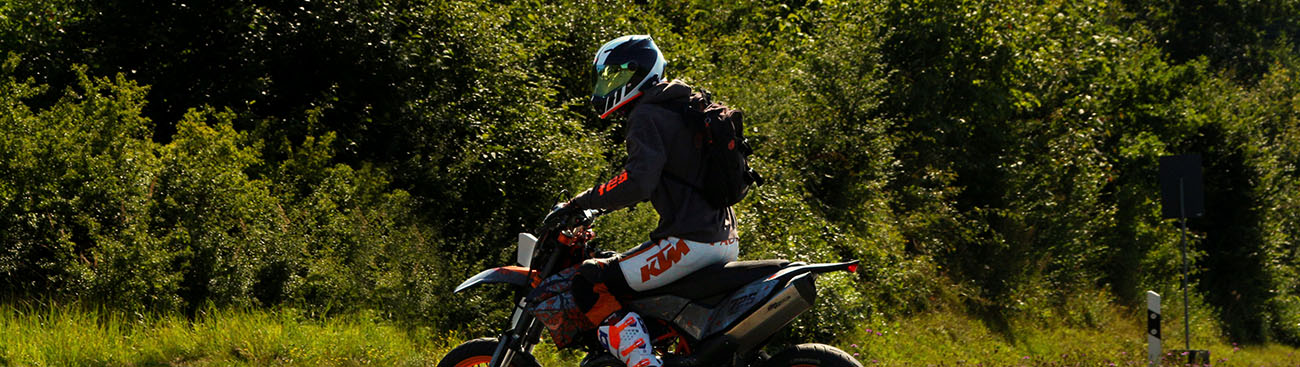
{"left": 664, "top": 91, "right": 763, "bottom": 208}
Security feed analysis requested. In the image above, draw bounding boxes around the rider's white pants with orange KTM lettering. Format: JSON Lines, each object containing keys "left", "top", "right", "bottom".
{"left": 619, "top": 237, "right": 740, "bottom": 292}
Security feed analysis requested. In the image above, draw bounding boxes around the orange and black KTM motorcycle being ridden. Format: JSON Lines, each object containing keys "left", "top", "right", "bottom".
{"left": 438, "top": 211, "right": 862, "bottom": 367}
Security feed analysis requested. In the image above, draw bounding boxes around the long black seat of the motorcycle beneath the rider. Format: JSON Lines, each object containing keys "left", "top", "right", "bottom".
{"left": 631, "top": 260, "right": 790, "bottom": 301}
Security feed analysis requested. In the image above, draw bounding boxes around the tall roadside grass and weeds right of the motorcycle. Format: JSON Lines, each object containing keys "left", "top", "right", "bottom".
{"left": 837, "top": 292, "right": 1300, "bottom": 366}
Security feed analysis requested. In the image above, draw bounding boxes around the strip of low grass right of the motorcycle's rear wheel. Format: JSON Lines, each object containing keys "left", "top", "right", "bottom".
{"left": 837, "top": 309, "right": 1300, "bottom": 366}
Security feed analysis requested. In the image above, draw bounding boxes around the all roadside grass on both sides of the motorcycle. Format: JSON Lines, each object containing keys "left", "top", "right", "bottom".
{"left": 0, "top": 300, "right": 1300, "bottom": 366}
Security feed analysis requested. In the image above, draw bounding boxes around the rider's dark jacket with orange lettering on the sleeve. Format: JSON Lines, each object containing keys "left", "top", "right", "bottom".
{"left": 572, "top": 81, "right": 736, "bottom": 242}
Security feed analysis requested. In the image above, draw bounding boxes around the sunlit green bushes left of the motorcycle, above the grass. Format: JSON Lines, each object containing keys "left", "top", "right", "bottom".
{"left": 0, "top": 57, "right": 450, "bottom": 324}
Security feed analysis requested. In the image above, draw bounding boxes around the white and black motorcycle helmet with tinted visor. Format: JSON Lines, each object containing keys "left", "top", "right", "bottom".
{"left": 592, "top": 35, "right": 668, "bottom": 118}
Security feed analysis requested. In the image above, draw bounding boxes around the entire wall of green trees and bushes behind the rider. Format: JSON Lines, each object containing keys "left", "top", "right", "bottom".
{"left": 0, "top": 0, "right": 1300, "bottom": 345}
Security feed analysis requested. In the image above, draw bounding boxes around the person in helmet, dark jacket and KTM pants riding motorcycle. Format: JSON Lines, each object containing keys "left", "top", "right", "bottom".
{"left": 543, "top": 35, "right": 740, "bottom": 367}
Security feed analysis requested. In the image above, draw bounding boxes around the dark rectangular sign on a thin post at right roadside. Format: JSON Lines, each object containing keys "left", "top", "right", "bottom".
{"left": 1160, "top": 154, "right": 1209, "bottom": 362}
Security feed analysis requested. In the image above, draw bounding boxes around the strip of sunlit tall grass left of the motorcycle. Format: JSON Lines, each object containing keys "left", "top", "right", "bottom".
{"left": 0, "top": 305, "right": 459, "bottom": 366}
